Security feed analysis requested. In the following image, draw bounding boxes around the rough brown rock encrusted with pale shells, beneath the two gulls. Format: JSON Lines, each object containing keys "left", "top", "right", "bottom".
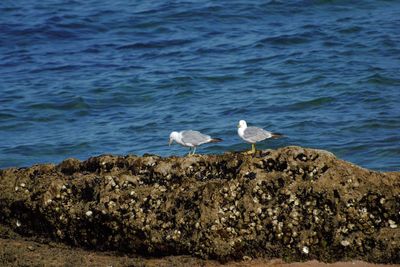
{"left": 0, "top": 147, "right": 400, "bottom": 263}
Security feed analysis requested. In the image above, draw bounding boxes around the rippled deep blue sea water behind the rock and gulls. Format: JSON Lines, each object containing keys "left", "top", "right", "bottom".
{"left": 0, "top": 0, "right": 400, "bottom": 171}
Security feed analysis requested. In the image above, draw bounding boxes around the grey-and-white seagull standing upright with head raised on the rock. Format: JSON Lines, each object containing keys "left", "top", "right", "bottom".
{"left": 237, "top": 120, "right": 283, "bottom": 154}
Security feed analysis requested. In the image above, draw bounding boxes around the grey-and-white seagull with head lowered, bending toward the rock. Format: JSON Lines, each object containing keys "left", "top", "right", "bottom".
{"left": 169, "top": 130, "right": 222, "bottom": 156}
